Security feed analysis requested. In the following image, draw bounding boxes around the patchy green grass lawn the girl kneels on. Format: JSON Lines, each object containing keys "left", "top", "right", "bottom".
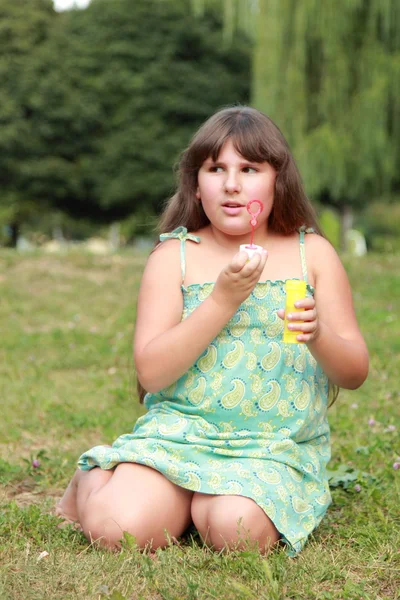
{"left": 0, "top": 250, "right": 400, "bottom": 600}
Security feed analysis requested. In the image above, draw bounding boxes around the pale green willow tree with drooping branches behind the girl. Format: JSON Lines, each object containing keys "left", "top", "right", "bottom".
{"left": 253, "top": 0, "right": 400, "bottom": 245}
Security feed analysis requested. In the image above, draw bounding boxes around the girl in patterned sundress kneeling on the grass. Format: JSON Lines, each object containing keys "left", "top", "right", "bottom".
{"left": 57, "top": 107, "right": 368, "bottom": 555}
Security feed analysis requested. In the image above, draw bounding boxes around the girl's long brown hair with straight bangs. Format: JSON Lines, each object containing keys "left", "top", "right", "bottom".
{"left": 138, "top": 105, "right": 337, "bottom": 403}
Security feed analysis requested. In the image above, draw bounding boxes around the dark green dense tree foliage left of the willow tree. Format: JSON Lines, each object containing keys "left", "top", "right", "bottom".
{"left": 0, "top": 0, "right": 250, "bottom": 241}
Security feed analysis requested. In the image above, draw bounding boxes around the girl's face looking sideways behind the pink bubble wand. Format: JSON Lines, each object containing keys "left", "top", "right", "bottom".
{"left": 196, "top": 140, "right": 276, "bottom": 236}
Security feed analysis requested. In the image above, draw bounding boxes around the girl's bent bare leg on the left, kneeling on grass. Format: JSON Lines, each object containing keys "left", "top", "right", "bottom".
{"left": 75, "top": 463, "right": 193, "bottom": 548}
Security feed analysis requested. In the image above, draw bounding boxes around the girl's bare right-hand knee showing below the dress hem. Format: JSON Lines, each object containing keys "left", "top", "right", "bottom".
{"left": 192, "top": 492, "right": 280, "bottom": 552}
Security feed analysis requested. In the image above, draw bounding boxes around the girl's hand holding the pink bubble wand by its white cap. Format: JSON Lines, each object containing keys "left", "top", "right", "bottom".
{"left": 211, "top": 250, "right": 268, "bottom": 309}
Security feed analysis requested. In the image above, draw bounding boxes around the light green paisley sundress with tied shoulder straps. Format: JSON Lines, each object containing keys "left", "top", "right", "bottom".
{"left": 79, "top": 227, "right": 331, "bottom": 555}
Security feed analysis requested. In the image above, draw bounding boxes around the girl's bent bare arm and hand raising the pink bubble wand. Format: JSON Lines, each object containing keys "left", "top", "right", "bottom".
{"left": 134, "top": 240, "right": 266, "bottom": 392}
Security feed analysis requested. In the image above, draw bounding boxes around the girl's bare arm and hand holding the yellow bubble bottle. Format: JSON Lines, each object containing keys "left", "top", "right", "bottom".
{"left": 280, "top": 235, "right": 368, "bottom": 389}
